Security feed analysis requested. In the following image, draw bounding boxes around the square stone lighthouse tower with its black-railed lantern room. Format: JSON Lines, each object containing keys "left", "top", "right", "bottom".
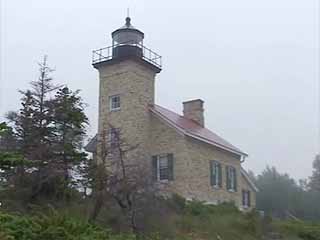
{"left": 93, "top": 17, "right": 161, "bottom": 165}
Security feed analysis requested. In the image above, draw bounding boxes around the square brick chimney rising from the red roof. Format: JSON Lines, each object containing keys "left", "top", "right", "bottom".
{"left": 183, "top": 99, "right": 204, "bottom": 127}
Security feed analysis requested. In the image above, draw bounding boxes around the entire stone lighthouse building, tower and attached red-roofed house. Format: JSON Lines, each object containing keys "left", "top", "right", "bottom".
{"left": 86, "top": 17, "right": 257, "bottom": 209}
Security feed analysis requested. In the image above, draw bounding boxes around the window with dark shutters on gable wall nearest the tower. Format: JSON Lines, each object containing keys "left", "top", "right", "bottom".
{"left": 152, "top": 153, "right": 173, "bottom": 181}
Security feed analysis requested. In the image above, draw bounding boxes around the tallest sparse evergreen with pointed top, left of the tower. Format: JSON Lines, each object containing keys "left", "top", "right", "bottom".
{"left": 7, "top": 56, "right": 58, "bottom": 199}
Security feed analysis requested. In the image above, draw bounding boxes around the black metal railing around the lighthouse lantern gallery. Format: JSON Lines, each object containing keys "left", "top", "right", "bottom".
{"left": 92, "top": 42, "right": 162, "bottom": 68}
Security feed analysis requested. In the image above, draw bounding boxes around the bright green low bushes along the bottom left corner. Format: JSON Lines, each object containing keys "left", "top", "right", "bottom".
{"left": 0, "top": 212, "right": 134, "bottom": 240}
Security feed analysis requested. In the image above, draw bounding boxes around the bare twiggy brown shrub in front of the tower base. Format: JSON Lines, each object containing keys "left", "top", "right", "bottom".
{"left": 91, "top": 125, "right": 156, "bottom": 234}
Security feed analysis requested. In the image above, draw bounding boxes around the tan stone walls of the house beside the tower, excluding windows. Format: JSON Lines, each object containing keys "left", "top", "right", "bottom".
{"left": 150, "top": 113, "right": 255, "bottom": 208}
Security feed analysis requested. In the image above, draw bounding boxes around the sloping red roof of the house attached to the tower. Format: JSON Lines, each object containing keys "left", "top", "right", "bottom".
{"left": 150, "top": 105, "right": 248, "bottom": 156}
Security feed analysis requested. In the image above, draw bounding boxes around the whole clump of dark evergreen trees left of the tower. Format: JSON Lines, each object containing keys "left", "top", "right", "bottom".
{"left": 0, "top": 57, "right": 88, "bottom": 203}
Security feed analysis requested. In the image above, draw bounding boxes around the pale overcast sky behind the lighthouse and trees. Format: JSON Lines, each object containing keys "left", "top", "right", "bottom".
{"left": 0, "top": 0, "right": 320, "bottom": 179}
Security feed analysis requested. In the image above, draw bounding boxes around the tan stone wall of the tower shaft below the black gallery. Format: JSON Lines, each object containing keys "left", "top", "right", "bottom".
{"left": 97, "top": 59, "right": 155, "bottom": 168}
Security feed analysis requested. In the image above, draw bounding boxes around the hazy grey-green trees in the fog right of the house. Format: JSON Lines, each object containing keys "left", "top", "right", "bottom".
{"left": 251, "top": 167, "right": 320, "bottom": 220}
